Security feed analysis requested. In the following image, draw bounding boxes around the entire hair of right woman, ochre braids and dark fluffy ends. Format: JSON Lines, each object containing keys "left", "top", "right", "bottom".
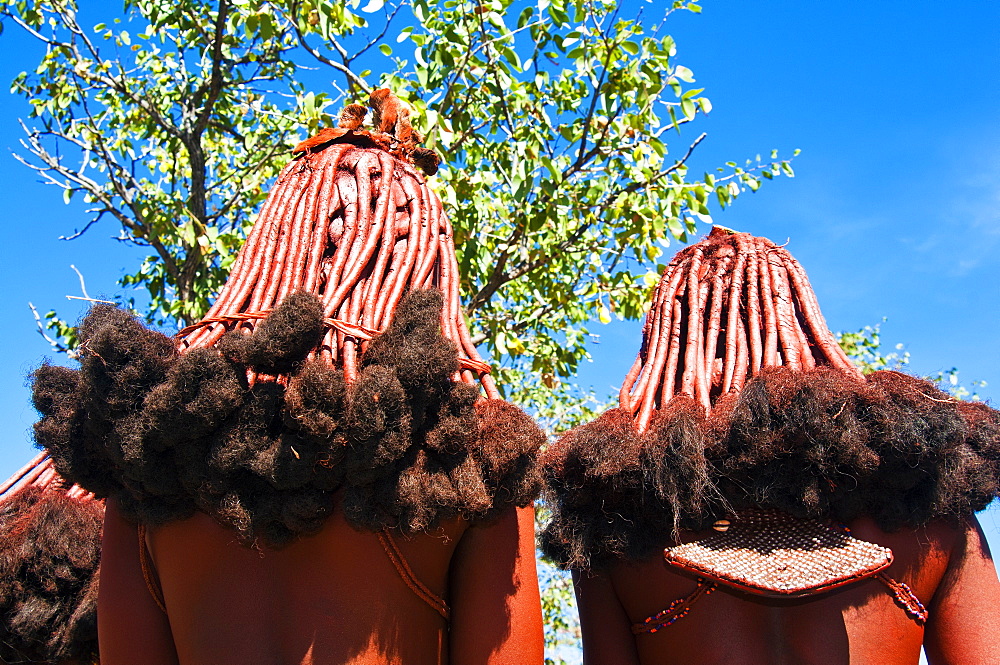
{"left": 542, "top": 228, "right": 1000, "bottom": 569}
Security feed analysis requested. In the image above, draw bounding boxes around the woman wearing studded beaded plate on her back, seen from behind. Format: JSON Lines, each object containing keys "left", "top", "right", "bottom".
{"left": 543, "top": 228, "right": 1000, "bottom": 665}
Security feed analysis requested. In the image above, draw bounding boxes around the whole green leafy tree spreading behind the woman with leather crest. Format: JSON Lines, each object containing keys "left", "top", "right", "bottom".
{"left": 2, "top": 0, "right": 792, "bottom": 425}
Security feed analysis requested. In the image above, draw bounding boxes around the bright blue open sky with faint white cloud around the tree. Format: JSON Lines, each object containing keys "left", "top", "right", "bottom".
{"left": 0, "top": 0, "right": 1000, "bottom": 547}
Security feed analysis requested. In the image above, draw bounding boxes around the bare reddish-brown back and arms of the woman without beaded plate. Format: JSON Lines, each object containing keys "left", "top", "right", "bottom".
{"left": 98, "top": 501, "right": 543, "bottom": 665}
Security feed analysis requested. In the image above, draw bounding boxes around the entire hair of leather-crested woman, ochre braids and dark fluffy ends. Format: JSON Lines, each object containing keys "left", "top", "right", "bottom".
{"left": 34, "top": 90, "right": 544, "bottom": 546}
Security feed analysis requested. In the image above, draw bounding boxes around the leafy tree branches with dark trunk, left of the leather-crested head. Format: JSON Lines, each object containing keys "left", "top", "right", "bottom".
{"left": 0, "top": 0, "right": 329, "bottom": 323}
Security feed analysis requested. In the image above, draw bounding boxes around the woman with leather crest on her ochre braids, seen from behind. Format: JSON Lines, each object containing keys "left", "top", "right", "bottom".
{"left": 35, "top": 90, "right": 543, "bottom": 665}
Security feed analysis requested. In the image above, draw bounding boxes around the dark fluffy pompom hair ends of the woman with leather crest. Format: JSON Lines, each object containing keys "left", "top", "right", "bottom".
{"left": 35, "top": 291, "right": 543, "bottom": 547}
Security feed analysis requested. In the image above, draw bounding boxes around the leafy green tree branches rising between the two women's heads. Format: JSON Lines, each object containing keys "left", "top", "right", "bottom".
{"left": 370, "top": 0, "right": 793, "bottom": 400}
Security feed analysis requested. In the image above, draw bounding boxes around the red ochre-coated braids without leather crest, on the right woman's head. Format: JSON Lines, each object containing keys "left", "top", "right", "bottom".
{"left": 619, "top": 227, "right": 858, "bottom": 432}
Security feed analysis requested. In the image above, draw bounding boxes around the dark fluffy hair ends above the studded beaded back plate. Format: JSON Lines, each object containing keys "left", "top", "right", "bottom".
{"left": 542, "top": 368, "right": 1000, "bottom": 568}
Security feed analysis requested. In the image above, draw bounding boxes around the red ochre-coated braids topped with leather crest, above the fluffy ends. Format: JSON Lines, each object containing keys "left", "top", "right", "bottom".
{"left": 179, "top": 90, "right": 499, "bottom": 398}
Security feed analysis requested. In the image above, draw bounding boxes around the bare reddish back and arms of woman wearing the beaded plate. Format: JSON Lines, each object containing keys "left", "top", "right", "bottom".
{"left": 574, "top": 517, "right": 1000, "bottom": 665}
